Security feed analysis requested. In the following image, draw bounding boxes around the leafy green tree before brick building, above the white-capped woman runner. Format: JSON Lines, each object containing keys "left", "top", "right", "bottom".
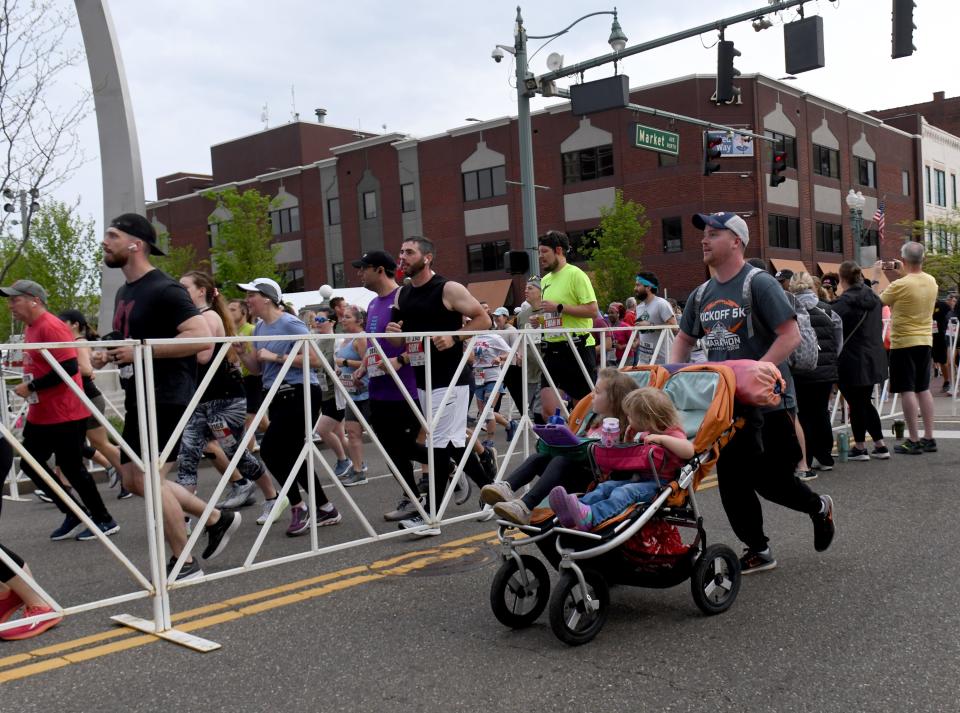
{"left": 204, "top": 188, "right": 280, "bottom": 297}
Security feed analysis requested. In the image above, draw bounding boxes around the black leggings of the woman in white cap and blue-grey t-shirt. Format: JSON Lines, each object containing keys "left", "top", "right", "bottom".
{"left": 260, "top": 384, "right": 327, "bottom": 507}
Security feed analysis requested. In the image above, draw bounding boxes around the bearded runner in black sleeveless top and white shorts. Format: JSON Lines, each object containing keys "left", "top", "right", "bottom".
{"left": 384, "top": 236, "right": 491, "bottom": 536}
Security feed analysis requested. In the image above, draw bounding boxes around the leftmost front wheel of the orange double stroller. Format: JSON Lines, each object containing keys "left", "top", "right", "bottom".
{"left": 490, "top": 555, "right": 550, "bottom": 629}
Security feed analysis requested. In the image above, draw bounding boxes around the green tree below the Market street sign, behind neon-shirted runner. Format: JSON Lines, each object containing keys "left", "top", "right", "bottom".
{"left": 584, "top": 190, "right": 650, "bottom": 309}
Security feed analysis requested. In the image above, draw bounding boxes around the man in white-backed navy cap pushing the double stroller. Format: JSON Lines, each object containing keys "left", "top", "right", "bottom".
{"left": 672, "top": 213, "right": 834, "bottom": 574}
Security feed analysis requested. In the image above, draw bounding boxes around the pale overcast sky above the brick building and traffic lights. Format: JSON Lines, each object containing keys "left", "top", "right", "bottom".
{"left": 50, "top": 0, "right": 960, "bottom": 232}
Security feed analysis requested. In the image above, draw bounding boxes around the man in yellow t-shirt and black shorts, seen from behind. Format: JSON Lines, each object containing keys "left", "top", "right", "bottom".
{"left": 878, "top": 241, "right": 937, "bottom": 455}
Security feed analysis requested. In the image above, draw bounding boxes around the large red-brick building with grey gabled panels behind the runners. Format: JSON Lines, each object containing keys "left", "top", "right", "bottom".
{"left": 148, "top": 75, "right": 922, "bottom": 304}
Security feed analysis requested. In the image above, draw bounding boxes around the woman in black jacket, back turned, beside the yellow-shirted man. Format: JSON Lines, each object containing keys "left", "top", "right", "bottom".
{"left": 831, "top": 260, "right": 890, "bottom": 461}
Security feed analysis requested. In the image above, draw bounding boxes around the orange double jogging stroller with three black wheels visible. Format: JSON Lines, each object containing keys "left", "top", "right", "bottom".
{"left": 490, "top": 364, "right": 740, "bottom": 645}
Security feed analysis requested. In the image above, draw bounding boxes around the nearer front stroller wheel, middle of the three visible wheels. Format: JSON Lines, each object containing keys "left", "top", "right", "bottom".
{"left": 550, "top": 569, "right": 610, "bottom": 646}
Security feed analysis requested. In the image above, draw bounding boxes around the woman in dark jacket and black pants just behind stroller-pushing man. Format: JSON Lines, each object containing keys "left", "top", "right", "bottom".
{"left": 790, "top": 272, "right": 843, "bottom": 472}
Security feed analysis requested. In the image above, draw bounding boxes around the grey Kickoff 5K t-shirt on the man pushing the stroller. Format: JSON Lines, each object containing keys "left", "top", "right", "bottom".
{"left": 680, "top": 265, "right": 797, "bottom": 410}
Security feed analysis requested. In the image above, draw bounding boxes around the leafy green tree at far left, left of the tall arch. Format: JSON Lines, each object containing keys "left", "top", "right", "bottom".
{"left": 0, "top": 201, "right": 101, "bottom": 334}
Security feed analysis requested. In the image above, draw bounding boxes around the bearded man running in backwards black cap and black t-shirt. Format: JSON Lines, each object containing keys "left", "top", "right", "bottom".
{"left": 92, "top": 213, "right": 240, "bottom": 581}
